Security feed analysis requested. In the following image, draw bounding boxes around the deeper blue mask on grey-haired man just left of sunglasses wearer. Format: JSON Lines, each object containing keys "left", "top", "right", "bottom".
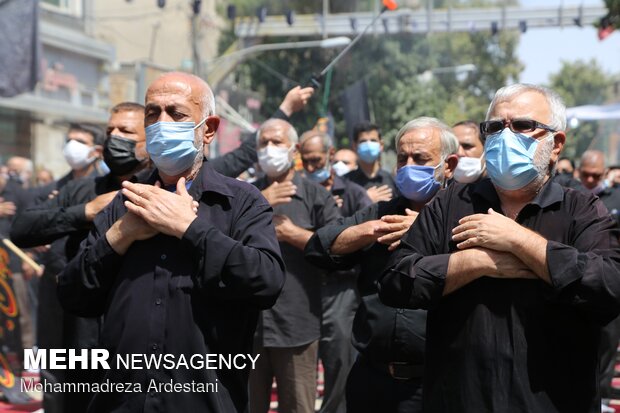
{"left": 396, "top": 160, "right": 443, "bottom": 202}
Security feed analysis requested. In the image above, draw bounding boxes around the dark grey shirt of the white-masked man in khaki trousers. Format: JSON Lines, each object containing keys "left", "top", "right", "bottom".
{"left": 255, "top": 173, "right": 340, "bottom": 347}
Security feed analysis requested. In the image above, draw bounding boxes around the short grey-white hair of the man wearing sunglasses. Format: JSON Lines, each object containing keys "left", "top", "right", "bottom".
{"left": 486, "top": 83, "right": 566, "bottom": 131}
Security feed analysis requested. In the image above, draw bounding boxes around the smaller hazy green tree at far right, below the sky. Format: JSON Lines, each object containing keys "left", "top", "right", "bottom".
{"left": 549, "top": 59, "right": 613, "bottom": 158}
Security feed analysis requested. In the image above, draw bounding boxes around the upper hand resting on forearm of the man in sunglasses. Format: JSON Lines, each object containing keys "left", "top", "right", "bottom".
{"left": 452, "top": 208, "right": 532, "bottom": 252}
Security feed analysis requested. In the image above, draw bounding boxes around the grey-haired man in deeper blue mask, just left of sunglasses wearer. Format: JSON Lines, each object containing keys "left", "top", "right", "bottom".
{"left": 305, "top": 117, "right": 459, "bottom": 412}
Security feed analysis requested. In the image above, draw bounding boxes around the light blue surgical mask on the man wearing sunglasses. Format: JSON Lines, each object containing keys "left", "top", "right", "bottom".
{"left": 484, "top": 128, "right": 553, "bottom": 191}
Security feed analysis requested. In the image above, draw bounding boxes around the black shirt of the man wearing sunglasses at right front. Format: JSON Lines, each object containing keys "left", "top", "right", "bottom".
{"left": 380, "top": 179, "right": 620, "bottom": 413}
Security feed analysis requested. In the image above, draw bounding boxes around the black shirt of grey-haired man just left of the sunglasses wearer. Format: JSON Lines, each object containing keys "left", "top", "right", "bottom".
{"left": 305, "top": 197, "right": 426, "bottom": 364}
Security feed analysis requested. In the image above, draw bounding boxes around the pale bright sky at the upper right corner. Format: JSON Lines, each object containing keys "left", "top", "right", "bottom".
{"left": 518, "top": 0, "right": 620, "bottom": 84}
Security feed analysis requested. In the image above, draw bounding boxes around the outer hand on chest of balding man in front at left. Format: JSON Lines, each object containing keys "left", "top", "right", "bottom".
{"left": 122, "top": 178, "right": 198, "bottom": 239}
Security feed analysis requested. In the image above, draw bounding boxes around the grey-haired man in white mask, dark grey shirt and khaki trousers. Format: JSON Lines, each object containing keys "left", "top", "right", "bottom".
{"left": 250, "top": 119, "right": 340, "bottom": 413}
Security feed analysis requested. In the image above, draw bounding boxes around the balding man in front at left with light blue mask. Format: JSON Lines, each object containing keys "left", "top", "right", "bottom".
{"left": 58, "top": 73, "right": 284, "bottom": 413}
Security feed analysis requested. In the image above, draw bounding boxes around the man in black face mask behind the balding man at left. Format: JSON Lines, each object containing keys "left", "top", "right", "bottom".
{"left": 11, "top": 102, "right": 149, "bottom": 412}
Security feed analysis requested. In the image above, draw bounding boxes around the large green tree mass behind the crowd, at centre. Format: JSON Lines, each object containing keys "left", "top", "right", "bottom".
{"left": 220, "top": 0, "right": 523, "bottom": 150}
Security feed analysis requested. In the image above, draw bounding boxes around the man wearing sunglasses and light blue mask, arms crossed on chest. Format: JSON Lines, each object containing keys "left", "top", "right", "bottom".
{"left": 379, "top": 84, "right": 620, "bottom": 413}
